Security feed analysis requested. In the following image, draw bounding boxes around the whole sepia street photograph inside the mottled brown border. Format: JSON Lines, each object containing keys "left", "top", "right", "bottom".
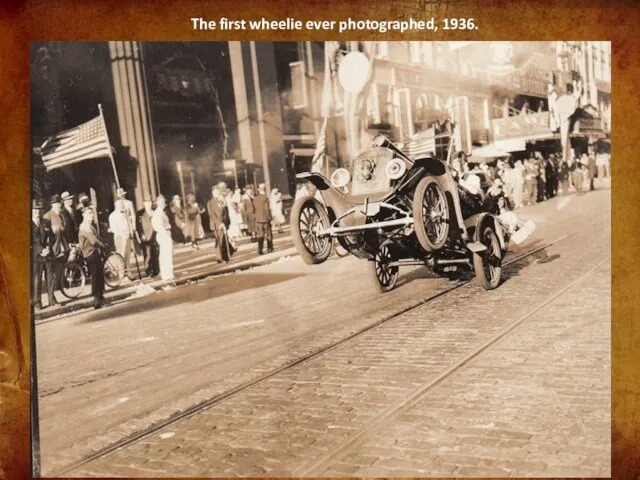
{"left": 29, "top": 41, "right": 617, "bottom": 478}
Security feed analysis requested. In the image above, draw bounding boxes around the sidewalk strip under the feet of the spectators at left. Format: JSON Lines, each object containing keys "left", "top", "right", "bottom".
{"left": 34, "top": 227, "right": 298, "bottom": 323}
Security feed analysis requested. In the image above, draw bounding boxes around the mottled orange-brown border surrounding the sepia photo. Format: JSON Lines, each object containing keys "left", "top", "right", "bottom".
{"left": 0, "top": 0, "right": 640, "bottom": 479}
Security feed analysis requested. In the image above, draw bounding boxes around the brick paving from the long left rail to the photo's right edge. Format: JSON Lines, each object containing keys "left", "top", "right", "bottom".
{"left": 58, "top": 188, "right": 610, "bottom": 477}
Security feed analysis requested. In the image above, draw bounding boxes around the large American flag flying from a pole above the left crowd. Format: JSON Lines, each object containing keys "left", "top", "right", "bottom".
{"left": 40, "top": 115, "right": 111, "bottom": 171}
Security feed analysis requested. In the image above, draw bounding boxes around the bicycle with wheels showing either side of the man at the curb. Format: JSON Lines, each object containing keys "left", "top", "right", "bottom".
{"left": 60, "top": 244, "right": 126, "bottom": 299}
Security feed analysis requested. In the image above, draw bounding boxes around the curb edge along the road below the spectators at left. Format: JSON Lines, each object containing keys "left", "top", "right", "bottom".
{"left": 33, "top": 247, "right": 299, "bottom": 325}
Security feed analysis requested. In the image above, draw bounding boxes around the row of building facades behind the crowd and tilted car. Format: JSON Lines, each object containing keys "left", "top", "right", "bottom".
{"left": 31, "top": 41, "right": 611, "bottom": 223}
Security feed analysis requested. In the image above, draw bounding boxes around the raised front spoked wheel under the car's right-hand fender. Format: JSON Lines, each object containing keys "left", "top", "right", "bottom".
{"left": 413, "top": 177, "right": 450, "bottom": 252}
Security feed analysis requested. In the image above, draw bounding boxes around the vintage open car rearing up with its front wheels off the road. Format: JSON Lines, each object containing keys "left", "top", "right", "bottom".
{"left": 290, "top": 135, "right": 507, "bottom": 292}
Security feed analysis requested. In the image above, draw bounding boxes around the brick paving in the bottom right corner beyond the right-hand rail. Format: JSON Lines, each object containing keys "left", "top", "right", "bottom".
{"left": 318, "top": 261, "right": 611, "bottom": 478}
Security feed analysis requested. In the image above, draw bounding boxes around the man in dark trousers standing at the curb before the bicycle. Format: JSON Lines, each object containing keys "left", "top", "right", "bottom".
{"left": 78, "top": 207, "right": 106, "bottom": 308}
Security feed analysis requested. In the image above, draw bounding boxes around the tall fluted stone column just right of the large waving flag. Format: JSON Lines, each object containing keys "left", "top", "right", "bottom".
{"left": 109, "top": 42, "right": 157, "bottom": 208}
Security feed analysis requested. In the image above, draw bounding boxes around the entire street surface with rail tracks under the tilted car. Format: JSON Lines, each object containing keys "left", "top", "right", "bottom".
{"left": 37, "top": 188, "right": 610, "bottom": 477}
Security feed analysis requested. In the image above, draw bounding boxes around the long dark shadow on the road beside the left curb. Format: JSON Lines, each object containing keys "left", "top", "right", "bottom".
{"left": 85, "top": 273, "right": 304, "bottom": 322}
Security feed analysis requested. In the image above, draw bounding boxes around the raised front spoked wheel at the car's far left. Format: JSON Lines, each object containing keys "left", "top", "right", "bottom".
{"left": 291, "top": 196, "right": 333, "bottom": 265}
